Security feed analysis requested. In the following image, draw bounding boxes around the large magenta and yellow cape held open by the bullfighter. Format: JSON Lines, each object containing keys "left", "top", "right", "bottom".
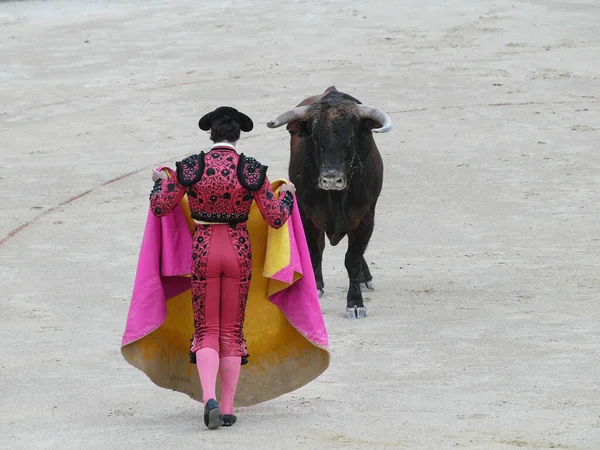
{"left": 121, "top": 180, "right": 330, "bottom": 406}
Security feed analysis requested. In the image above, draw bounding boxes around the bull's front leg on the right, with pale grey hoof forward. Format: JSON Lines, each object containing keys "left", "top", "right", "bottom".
{"left": 345, "top": 212, "right": 374, "bottom": 319}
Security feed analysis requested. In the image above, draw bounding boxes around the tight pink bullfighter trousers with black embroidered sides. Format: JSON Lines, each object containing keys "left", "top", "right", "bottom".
{"left": 192, "top": 223, "right": 252, "bottom": 358}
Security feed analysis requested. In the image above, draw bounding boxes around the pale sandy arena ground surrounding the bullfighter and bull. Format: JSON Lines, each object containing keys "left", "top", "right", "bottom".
{"left": 0, "top": 0, "right": 600, "bottom": 450}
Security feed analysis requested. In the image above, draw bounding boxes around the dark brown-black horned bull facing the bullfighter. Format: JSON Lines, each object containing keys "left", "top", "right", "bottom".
{"left": 267, "top": 87, "right": 391, "bottom": 318}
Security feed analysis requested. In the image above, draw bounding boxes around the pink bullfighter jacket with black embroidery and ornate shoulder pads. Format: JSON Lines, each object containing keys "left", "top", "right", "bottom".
{"left": 150, "top": 147, "right": 294, "bottom": 228}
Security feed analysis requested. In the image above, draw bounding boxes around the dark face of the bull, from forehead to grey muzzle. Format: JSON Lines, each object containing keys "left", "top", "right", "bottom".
{"left": 306, "top": 110, "right": 360, "bottom": 191}
